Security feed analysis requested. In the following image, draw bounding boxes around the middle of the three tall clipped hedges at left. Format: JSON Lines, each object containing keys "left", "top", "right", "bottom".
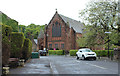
{"left": 11, "top": 32, "right": 24, "bottom": 58}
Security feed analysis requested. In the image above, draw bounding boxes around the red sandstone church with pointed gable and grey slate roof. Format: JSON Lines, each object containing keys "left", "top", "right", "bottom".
{"left": 37, "top": 11, "right": 83, "bottom": 51}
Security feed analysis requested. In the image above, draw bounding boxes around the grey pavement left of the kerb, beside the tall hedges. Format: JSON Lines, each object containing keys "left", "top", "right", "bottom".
{"left": 10, "top": 57, "right": 51, "bottom": 74}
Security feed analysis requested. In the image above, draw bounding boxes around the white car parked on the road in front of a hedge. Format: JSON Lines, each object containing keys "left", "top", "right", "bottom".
{"left": 76, "top": 48, "right": 97, "bottom": 60}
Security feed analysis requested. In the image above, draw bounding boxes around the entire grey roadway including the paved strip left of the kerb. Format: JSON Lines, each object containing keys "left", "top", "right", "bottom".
{"left": 10, "top": 56, "right": 118, "bottom": 76}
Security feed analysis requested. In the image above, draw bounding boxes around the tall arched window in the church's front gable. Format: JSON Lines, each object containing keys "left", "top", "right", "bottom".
{"left": 52, "top": 21, "right": 61, "bottom": 37}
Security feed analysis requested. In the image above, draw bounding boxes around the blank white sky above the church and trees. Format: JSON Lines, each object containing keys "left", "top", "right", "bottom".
{"left": 0, "top": 0, "right": 90, "bottom": 26}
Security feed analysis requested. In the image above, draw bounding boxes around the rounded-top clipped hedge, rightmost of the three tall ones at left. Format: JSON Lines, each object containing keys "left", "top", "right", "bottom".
{"left": 22, "top": 38, "right": 32, "bottom": 60}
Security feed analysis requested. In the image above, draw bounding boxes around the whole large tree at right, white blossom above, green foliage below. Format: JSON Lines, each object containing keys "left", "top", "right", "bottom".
{"left": 78, "top": 1, "right": 120, "bottom": 47}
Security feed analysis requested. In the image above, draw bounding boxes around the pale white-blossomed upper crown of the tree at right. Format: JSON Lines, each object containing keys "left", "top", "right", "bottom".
{"left": 80, "top": 1, "right": 120, "bottom": 32}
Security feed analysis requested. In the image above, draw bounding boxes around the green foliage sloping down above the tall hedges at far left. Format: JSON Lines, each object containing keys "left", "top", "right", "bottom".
{"left": 0, "top": 13, "right": 18, "bottom": 32}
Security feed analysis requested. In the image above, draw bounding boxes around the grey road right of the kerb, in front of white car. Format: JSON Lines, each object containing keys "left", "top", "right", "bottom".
{"left": 48, "top": 56, "right": 118, "bottom": 74}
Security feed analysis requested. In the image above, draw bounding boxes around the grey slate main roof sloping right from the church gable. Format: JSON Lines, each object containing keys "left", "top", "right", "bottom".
{"left": 59, "top": 14, "right": 83, "bottom": 33}
